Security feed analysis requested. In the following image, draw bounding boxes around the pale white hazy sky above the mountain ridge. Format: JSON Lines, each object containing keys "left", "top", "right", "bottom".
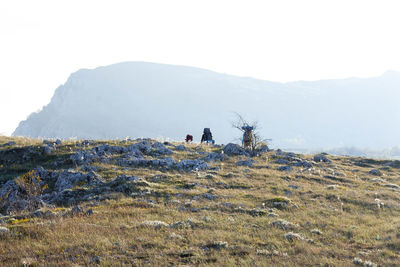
{"left": 0, "top": 0, "right": 400, "bottom": 134}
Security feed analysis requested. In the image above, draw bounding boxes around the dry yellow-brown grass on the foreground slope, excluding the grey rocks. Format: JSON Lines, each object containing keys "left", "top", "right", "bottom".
{"left": 0, "top": 137, "right": 400, "bottom": 266}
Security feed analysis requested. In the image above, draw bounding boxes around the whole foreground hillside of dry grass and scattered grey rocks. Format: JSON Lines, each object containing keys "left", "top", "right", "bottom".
{"left": 0, "top": 137, "right": 400, "bottom": 266}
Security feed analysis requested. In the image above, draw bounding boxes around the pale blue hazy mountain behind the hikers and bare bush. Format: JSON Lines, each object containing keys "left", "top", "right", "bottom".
{"left": 13, "top": 62, "right": 400, "bottom": 152}
